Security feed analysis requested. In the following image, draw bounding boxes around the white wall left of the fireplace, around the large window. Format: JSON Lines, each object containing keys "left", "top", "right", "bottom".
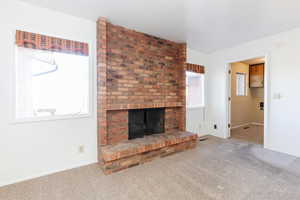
{"left": 0, "top": 0, "right": 97, "bottom": 186}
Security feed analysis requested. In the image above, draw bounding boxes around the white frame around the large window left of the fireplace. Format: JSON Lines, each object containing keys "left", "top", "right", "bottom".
{"left": 10, "top": 41, "right": 96, "bottom": 124}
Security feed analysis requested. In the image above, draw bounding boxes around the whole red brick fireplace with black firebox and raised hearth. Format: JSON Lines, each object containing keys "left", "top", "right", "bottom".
{"left": 97, "top": 18, "right": 197, "bottom": 174}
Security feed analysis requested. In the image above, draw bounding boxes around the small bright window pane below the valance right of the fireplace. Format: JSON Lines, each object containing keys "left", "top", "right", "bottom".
{"left": 186, "top": 72, "right": 204, "bottom": 107}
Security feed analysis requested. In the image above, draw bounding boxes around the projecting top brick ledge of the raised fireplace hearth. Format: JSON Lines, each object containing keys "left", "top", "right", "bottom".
{"left": 101, "top": 131, "right": 198, "bottom": 162}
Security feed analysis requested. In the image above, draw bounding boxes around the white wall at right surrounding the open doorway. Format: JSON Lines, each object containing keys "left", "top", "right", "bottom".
{"left": 207, "top": 29, "right": 300, "bottom": 156}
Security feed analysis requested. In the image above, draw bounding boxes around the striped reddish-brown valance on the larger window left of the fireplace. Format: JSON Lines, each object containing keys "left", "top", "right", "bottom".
{"left": 16, "top": 31, "right": 89, "bottom": 56}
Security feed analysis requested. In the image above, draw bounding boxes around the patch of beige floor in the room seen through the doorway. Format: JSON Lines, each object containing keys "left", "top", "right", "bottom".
{"left": 231, "top": 125, "right": 264, "bottom": 144}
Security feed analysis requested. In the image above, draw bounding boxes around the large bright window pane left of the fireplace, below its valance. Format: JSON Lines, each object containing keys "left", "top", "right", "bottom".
{"left": 15, "top": 47, "right": 89, "bottom": 119}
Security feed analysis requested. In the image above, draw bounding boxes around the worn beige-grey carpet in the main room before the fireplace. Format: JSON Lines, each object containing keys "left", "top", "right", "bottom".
{"left": 0, "top": 136, "right": 300, "bottom": 200}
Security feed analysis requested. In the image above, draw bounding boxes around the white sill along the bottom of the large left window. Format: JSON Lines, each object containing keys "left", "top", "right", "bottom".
{"left": 12, "top": 113, "right": 92, "bottom": 124}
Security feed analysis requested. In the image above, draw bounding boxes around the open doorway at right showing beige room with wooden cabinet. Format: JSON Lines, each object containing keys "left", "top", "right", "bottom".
{"left": 228, "top": 57, "right": 265, "bottom": 145}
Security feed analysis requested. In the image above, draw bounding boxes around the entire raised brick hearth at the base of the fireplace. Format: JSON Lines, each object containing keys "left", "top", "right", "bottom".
{"left": 101, "top": 131, "right": 197, "bottom": 174}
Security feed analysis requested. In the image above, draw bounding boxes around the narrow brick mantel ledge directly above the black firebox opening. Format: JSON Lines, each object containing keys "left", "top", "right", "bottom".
{"left": 106, "top": 102, "right": 183, "bottom": 110}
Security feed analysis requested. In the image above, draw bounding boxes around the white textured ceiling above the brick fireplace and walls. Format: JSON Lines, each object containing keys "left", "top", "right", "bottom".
{"left": 22, "top": 0, "right": 300, "bottom": 53}
